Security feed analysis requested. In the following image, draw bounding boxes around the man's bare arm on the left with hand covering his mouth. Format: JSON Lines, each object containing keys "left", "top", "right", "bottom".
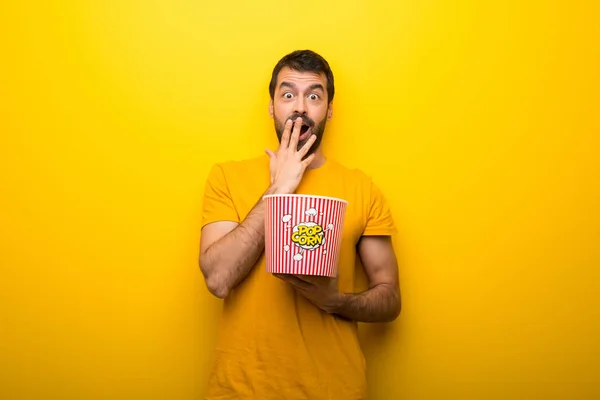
{"left": 199, "top": 118, "right": 316, "bottom": 299}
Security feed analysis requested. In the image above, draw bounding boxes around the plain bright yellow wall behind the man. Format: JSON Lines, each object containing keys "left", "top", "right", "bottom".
{"left": 0, "top": 0, "right": 600, "bottom": 400}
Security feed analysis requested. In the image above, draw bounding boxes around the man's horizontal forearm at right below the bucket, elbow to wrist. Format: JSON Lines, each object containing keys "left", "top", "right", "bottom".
{"left": 328, "top": 283, "right": 401, "bottom": 322}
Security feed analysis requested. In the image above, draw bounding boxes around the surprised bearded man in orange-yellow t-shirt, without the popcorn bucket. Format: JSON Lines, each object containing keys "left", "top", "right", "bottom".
{"left": 200, "top": 50, "right": 400, "bottom": 400}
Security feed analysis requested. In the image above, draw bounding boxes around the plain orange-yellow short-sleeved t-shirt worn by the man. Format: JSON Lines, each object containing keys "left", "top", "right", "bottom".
{"left": 202, "top": 155, "right": 396, "bottom": 400}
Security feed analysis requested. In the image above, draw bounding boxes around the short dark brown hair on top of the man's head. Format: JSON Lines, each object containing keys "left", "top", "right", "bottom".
{"left": 269, "top": 50, "right": 335, "bottom": 103}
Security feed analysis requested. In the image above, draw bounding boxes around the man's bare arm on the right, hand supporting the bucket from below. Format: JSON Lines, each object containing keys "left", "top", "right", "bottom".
{"left": 276, "top": 236, "right": 401, "bottom": 322}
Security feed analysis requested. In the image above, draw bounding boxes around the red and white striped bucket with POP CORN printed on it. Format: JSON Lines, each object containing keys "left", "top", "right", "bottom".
{"left": 263, "top": 194, "right": 348, "bottom": 277}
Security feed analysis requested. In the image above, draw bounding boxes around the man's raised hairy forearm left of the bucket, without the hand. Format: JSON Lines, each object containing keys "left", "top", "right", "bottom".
{"left": 200, "top": 184, "right": 284, "bottom": 298}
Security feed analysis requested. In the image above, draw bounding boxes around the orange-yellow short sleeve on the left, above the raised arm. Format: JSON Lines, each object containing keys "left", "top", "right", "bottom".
{"left": 201, "top": 164, "right": 240, "bottom": 227}
